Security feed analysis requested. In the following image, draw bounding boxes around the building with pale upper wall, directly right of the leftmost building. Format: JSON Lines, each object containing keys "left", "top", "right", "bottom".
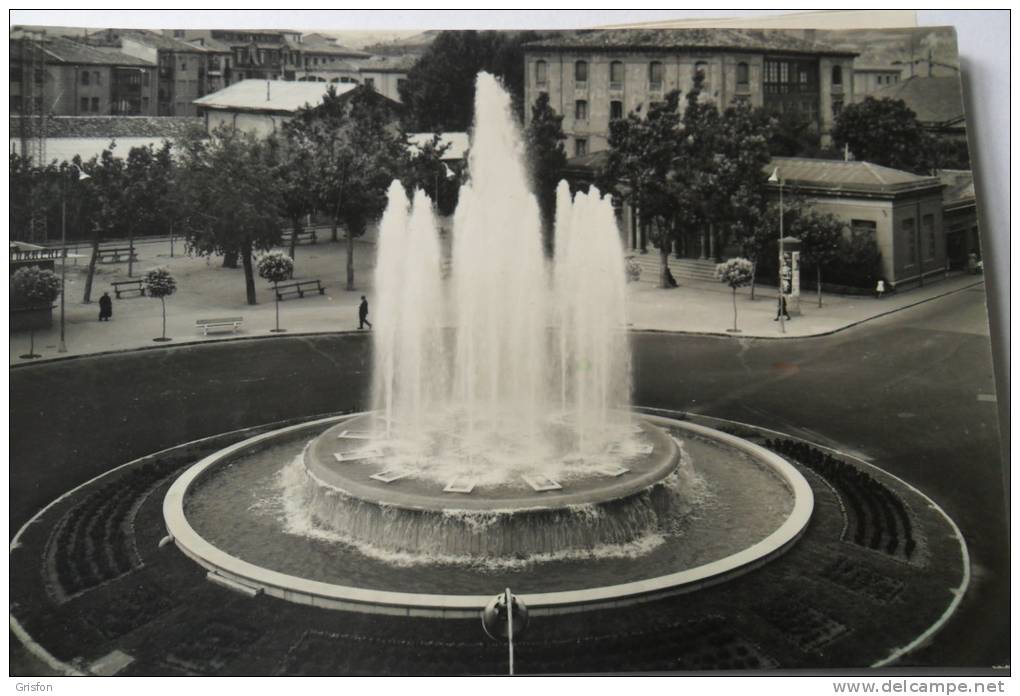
{"left": 89, "top": 29, "right": 214, "bottom": 116}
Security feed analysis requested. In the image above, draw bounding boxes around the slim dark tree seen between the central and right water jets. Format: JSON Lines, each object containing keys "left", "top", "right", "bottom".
{"left": 524, "top": 92, "right": 567, "bottom": 248}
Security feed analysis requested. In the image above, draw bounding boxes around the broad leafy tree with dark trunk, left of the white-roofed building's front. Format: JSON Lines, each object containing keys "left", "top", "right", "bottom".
{"left": 177, "top": 127, "right": 282, "bottom": 304}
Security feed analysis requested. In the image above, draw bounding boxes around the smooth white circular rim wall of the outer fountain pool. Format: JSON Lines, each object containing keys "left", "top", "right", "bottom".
{"left": 163, "top": 416, "right": 814, "bottom": 617}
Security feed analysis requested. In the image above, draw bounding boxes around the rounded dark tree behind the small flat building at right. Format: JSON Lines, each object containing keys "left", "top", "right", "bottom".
{"left": 832, "top": 97, "right": 927, "bottom": 172}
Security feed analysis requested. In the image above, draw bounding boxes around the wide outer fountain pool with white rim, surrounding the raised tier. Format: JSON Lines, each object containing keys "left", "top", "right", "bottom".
{"left": 163, "top": 416, "right": 814, "bottom": 617}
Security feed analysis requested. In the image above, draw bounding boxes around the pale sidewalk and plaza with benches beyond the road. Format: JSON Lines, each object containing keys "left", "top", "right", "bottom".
{"left": 9, "top": 235, "right": 984, "bottom": 364}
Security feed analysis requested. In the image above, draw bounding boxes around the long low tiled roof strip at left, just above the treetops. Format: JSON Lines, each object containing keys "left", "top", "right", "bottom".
{"left": 9, "top": 116, "right": 204, "bottom": 142}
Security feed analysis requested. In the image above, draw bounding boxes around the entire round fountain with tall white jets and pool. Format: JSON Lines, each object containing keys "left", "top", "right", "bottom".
{"left": 164, "top": 73, "right": 811, "bottom": 615}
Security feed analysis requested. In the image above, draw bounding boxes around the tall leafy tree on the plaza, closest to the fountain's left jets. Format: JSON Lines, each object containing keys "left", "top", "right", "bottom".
{"left": 286, "top": 87, "right": 407, "bottom": 290}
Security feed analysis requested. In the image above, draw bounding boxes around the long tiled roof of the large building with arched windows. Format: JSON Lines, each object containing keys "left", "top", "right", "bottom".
{"left": 524, "top": 29, "right": 857, "bottom": 56}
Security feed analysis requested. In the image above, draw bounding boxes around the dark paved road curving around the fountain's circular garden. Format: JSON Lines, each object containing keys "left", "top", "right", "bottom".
{"left": 10, "top": 289, "right": 1009, "bottom": 666}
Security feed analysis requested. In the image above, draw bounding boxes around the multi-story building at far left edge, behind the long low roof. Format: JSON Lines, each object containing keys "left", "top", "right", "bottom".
{"left": 9, "top": 34, "right": 158, "bottom": 116}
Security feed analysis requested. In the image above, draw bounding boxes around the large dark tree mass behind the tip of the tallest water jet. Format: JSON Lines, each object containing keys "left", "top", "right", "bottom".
{"left": 400, "top": 31, "right": 545, "bottom": 132}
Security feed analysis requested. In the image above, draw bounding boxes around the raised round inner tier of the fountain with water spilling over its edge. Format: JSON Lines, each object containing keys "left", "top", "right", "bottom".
{"left": 304, "top": 416, "right": 683, "bottom": 561}
